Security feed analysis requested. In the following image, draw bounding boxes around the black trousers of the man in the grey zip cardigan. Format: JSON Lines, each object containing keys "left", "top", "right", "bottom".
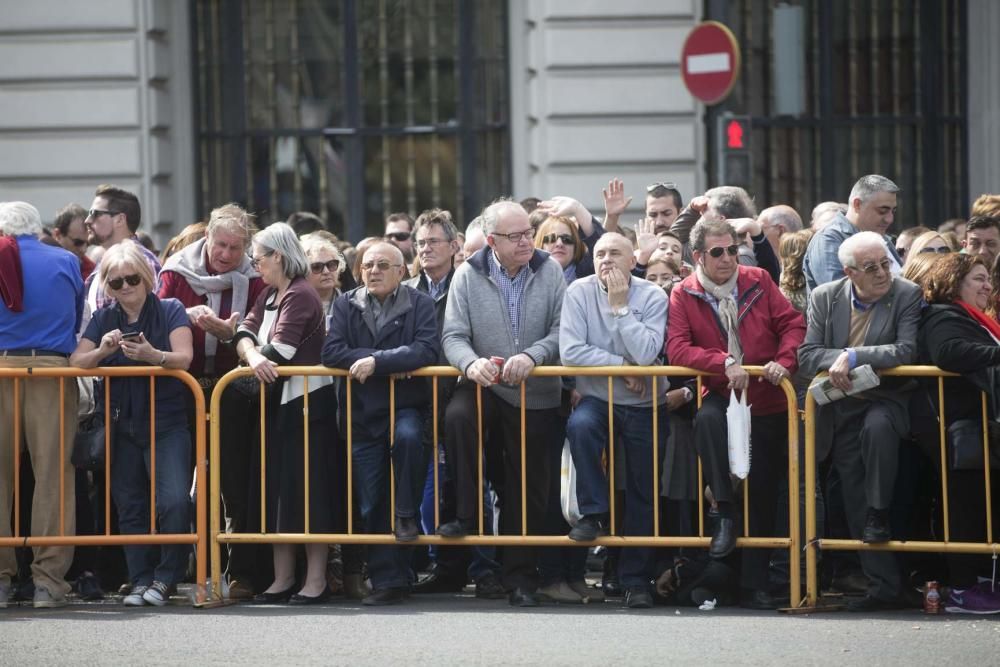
{"left": 445, "top": 382, "right": 561, "bottom": 590}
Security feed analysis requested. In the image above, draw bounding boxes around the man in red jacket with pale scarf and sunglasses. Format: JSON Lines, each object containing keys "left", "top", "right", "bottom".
{"left": 667, "top": 218, "right": 806, "bottom": 609}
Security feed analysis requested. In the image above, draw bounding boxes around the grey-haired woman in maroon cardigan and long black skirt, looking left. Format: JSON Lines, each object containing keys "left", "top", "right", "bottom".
{"left": 233, "top": 222, "right": 344, "bottom": 605}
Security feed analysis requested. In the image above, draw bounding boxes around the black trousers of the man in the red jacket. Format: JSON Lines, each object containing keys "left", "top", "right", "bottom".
{"left": 694, "top": 394, "right": 788, "bottom": 590}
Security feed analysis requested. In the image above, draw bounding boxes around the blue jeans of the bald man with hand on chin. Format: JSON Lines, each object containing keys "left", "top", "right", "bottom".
{"left": 566, "top": 396, "right": 668, "bottom": 587}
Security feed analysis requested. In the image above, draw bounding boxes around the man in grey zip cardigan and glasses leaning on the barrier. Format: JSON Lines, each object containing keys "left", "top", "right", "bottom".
{"left": 438, "top": 200, "right": 566, "bottom": 606}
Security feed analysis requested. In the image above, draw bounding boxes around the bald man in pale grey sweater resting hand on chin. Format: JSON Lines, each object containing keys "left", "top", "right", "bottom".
{"left": 559, "top": 232, "right": 669, "bottom": 609}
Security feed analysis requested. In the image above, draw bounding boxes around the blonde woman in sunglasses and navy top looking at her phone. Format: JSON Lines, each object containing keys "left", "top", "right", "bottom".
{"left": 70, "top": 243, "right": 193, "bottom": 607}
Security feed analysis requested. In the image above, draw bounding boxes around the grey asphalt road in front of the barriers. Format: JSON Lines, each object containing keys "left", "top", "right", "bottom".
{"left": 0, "top": 594, "right": 1000, "bottom": 667}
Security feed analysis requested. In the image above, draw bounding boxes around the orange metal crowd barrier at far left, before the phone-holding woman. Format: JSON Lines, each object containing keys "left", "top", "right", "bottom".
{"left": 0, "top": 366, "right": 208, "bottom": 604}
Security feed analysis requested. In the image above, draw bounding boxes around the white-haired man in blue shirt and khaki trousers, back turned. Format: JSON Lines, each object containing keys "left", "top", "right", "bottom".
{"left": 0, "top": 202, "right": 83, "bottom": 608}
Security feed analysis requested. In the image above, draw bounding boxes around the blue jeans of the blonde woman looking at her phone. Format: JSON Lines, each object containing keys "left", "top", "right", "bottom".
{"left": 111, "top": 420, "right": 192, "bottom": 586}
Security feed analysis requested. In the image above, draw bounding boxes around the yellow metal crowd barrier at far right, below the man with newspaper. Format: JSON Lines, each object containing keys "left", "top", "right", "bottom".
{"left": 804, "top": 366, "right": 1000, "bottom": 607}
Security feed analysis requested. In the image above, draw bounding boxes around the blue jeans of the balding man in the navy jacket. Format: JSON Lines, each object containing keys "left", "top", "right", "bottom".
{"left": 352, "top": 408, "right": 427, "bottom": 590}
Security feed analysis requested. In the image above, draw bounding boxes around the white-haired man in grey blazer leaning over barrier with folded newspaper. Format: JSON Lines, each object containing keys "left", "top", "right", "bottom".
{"left": 799, "top": 232, "right": 922, "bottom": 611}
